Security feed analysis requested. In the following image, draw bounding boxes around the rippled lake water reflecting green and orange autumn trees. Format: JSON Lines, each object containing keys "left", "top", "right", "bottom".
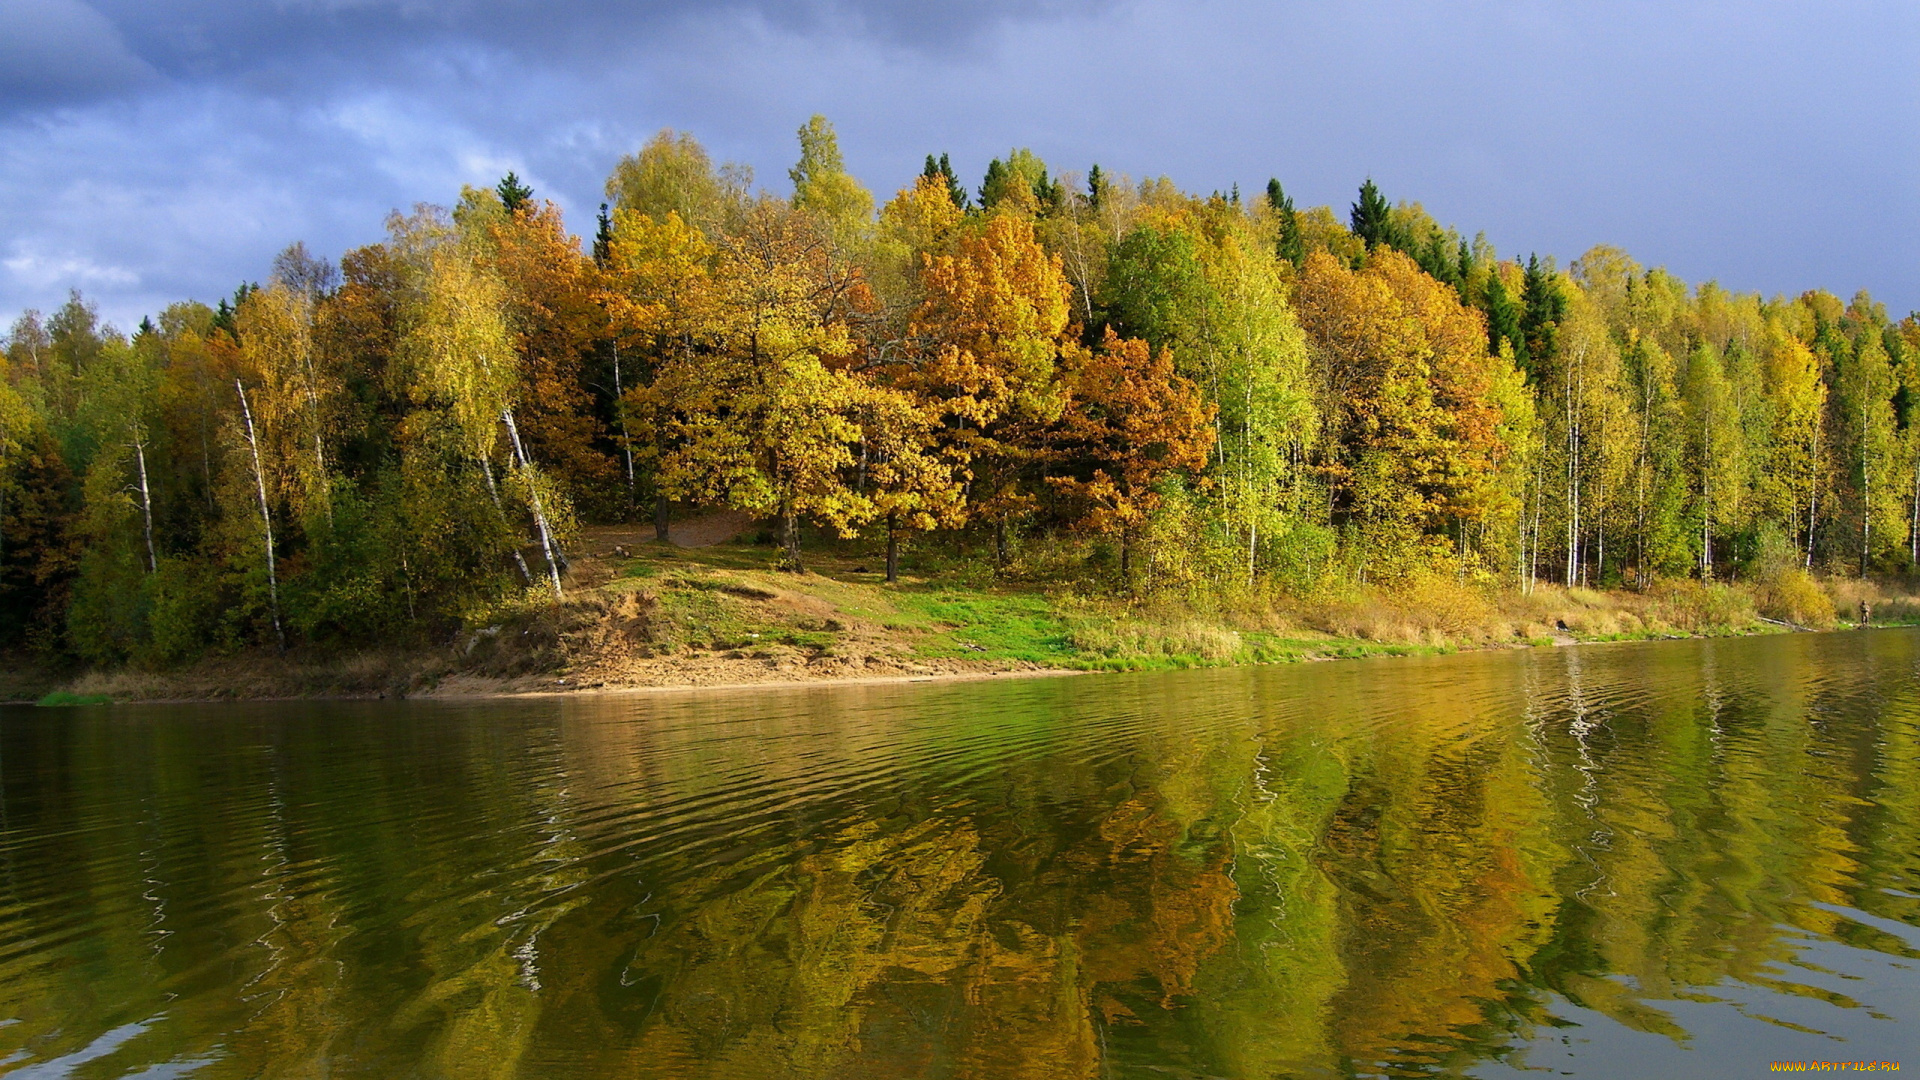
{"left": 0, "top": 630, "right": 1920, "bottom": 1080}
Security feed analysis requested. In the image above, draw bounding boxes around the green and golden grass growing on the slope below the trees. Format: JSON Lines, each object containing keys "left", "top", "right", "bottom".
{"left": 560, "top": 540, "right": 1835, "bottom": 671}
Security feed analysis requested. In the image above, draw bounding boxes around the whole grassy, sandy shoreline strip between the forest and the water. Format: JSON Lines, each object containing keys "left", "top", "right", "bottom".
{"left": 0, "top": 530, "right": 1920, "bottom": 703}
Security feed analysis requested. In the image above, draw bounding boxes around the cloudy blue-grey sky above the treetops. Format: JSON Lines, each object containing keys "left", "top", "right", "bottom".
{"left": 0, "top": 0, "right": 1920, "bottom": 327}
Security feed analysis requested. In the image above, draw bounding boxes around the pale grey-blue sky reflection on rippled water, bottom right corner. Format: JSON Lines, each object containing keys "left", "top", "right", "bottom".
{"left": 1469, "top": 903, "right": 1920, "bottom": 1080}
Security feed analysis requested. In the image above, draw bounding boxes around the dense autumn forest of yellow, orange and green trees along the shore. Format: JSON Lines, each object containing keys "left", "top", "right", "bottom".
{"left": 0, "top": 117, "right": 1920, "bottom": 665}
